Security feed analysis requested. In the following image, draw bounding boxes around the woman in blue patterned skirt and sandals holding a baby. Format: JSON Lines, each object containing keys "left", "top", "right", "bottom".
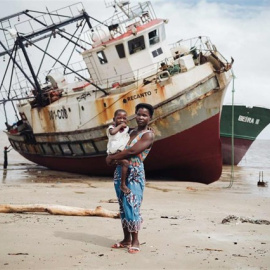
{"left": 106, "top": 103, "right": 155, "bottom": 254}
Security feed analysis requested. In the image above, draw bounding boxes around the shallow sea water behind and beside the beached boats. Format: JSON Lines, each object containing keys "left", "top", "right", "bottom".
{"left": 0, "top": 131, "right": 270, "bottom": 197}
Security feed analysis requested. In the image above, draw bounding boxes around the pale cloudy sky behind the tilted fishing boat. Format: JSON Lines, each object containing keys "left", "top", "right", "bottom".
{"left": 0, "top": 0, "right": 270, "bottom": 139}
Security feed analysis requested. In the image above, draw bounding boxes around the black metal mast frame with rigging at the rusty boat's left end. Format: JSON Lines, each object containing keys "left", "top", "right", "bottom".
{"left": 0, "top": 4, "right": 107, "bottom": 107}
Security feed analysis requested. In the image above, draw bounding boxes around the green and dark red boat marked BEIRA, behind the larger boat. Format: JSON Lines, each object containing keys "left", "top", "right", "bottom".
{"left": 220, "top": 105, "right": 270, "bottom": 165}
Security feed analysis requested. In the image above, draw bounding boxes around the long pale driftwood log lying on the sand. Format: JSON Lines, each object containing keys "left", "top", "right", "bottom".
{"left": 0, "top": 204, "right": 120, "bottom": 218}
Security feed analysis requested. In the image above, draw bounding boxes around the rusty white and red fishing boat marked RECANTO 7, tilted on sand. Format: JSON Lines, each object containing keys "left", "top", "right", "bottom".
{"left": 0, "top": 1, "right": 232, "bottom": 184}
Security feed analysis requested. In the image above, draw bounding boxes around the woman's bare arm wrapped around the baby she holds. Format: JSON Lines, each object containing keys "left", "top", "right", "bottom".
{"left": 106, "top": 132, "right": 155, "bottom": 165}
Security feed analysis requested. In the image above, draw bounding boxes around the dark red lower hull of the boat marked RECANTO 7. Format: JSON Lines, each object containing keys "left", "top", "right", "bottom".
{"left": 20, "top": 114, "right": 222, "bottom": 184}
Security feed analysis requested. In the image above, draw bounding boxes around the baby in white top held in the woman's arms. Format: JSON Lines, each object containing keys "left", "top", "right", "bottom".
{"left": 107, "top": 109, "right": 130, "bottom": 194}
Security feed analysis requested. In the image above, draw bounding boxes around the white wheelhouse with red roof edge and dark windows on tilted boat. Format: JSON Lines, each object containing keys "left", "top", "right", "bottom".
{"left": 82, "top": 19, "right": 171, "bottom": 88}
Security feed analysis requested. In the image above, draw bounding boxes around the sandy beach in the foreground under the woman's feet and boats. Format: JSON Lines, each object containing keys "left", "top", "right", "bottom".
{"left": 0, "top": 163, "right": 270, "bottom": 269}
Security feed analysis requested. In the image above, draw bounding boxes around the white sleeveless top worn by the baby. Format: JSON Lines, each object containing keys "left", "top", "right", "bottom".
{"left": 107, "top": 125, "right": 130, "bottom": 154}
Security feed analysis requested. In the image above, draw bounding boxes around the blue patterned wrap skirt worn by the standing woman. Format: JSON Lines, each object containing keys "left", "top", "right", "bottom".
{"left": 114, "top": 163, "right": 145, "bottom": 232}
